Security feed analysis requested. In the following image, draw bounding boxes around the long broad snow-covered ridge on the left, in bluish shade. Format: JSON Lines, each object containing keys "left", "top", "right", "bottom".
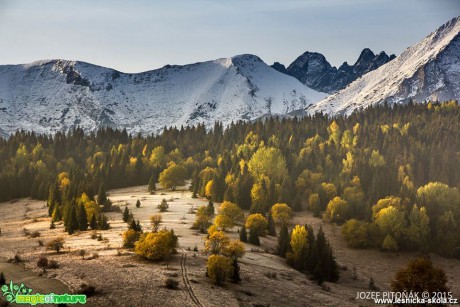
{"left": 0, "top": 55, "right": 326, "bottom": 136}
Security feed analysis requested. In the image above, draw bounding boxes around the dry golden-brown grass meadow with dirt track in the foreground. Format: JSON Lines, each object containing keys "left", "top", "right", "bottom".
{"left": 0, "top": 186, "right": 460, "bottom": 307}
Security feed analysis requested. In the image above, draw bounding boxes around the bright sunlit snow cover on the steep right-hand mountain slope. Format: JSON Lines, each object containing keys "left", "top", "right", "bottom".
{"left": 307, "top": 17, "right": 460, "bottom": 114}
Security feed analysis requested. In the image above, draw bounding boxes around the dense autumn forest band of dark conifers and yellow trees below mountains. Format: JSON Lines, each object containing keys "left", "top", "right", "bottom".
{"left": 0, "top": 101, "right": 460, "bottom": 255}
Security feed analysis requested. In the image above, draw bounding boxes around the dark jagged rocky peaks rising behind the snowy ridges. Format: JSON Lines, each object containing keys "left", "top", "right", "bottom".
{"left": 271, "top": 48, "right": 396, "bottom": 93}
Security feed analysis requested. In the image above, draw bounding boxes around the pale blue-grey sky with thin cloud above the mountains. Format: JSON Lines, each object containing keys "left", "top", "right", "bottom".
{"left": 0, "top": 0, "right": 460, "bottom": 73}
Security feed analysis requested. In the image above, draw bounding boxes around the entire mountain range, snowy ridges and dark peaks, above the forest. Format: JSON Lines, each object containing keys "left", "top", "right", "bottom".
{"left": 0, "top": 17, "right": 460, "bottom": 136}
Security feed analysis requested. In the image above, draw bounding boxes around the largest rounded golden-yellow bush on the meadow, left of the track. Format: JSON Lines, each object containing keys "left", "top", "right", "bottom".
{"left": 134, "top": 230, "right": 177, "bottom": 261}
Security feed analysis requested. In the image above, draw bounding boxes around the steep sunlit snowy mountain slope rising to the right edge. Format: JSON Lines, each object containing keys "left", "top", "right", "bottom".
{"left": 306, "top": 17, "right": 460, "bottom": 115}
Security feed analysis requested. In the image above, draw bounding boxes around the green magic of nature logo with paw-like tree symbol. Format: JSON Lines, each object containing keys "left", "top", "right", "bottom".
{"left": 2, "top": 281, "right": 86, "bottom": 305}
